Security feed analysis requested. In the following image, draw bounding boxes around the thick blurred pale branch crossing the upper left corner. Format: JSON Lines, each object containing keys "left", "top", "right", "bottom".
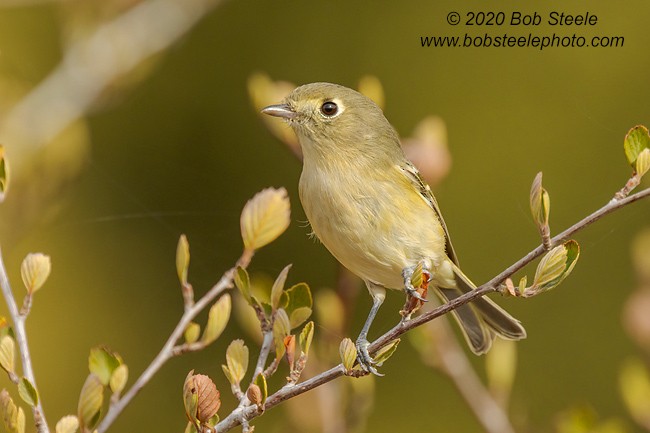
{"left": 0, "top": 0, "right": 228, "bottom": 162}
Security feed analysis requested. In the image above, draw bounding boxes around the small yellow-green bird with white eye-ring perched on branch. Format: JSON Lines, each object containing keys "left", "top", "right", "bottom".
{"left": 262, "top": 83, "right": 526, "bottom": 374}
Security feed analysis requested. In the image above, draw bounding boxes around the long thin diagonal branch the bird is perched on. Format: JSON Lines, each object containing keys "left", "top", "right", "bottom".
{"left": 216, "top": 188, "right": 650, "bottom": 432}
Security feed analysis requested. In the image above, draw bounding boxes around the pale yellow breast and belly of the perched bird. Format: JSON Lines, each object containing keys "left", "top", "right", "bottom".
{"left": 300, "top": 165, "right": 445, "bottom": 289}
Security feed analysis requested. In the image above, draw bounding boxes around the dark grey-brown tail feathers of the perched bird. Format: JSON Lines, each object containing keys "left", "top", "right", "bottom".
{"left": 437, "top": 265, "right": 526, "bottom": 355}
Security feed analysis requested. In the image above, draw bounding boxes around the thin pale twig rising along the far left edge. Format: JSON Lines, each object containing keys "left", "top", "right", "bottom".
{"left": 0, "top": 251, "right": 50, "bottom": 433}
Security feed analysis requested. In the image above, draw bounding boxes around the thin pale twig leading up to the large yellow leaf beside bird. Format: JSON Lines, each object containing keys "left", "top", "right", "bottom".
{"left": 97, "top": 248, "right": 251, "bottom": 433}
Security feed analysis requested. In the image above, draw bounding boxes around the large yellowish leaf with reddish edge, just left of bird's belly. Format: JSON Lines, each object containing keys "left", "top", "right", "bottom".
{"left": 240, "top": 188, "right": 291, "bottom": 250}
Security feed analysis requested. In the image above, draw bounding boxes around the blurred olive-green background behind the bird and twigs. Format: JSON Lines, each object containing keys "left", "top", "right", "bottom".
{"left": 0, "top": 0, "right": 650, "bottom": 432}
